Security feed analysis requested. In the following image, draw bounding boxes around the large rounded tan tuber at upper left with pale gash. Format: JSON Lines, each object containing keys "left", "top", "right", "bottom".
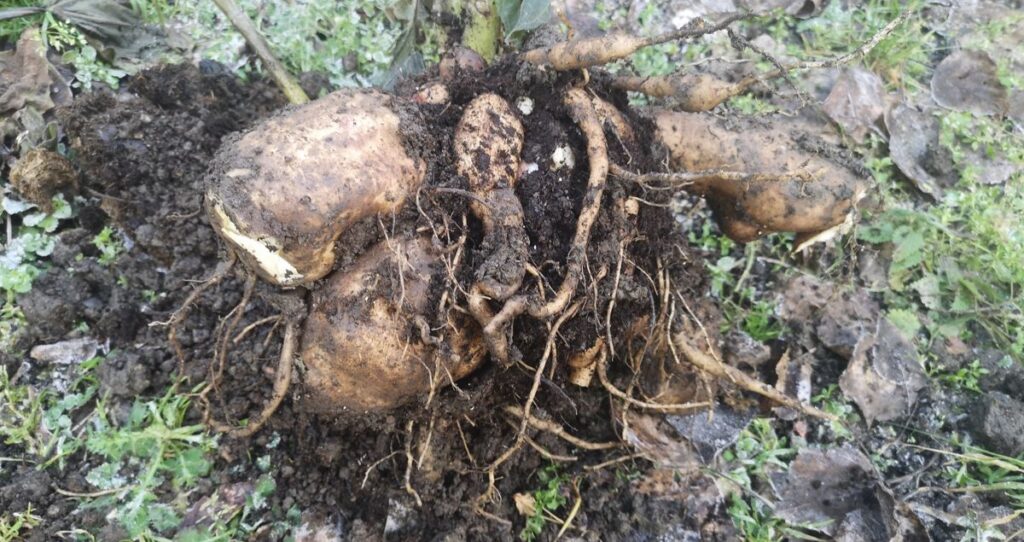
{"left": 206, "top": 90, "right": 426, "bottom": 286}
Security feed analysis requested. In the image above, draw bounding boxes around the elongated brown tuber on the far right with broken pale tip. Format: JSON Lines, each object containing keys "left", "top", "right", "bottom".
{"left": 655, "top": 112, "right": 867, "bottom": 241}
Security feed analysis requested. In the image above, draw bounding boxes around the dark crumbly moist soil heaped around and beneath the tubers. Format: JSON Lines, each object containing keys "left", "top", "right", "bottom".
{"left": 0, "top": 60, "right": 734, "bottom": 540}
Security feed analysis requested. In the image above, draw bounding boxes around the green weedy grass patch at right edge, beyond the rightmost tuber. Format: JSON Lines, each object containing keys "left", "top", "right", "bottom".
{"left": 857, "top": 113, "right": 1024, "bottom": 361}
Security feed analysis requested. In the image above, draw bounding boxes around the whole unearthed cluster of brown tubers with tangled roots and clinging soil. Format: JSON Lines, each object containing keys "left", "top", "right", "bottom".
{"left": 190, "top": 10, "right": 867, "bottom": 424}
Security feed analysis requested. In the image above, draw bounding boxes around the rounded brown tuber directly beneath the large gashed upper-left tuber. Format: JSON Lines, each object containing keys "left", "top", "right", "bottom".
{"left": 299, "top": 237, "right": 486, "bottom": 413}
